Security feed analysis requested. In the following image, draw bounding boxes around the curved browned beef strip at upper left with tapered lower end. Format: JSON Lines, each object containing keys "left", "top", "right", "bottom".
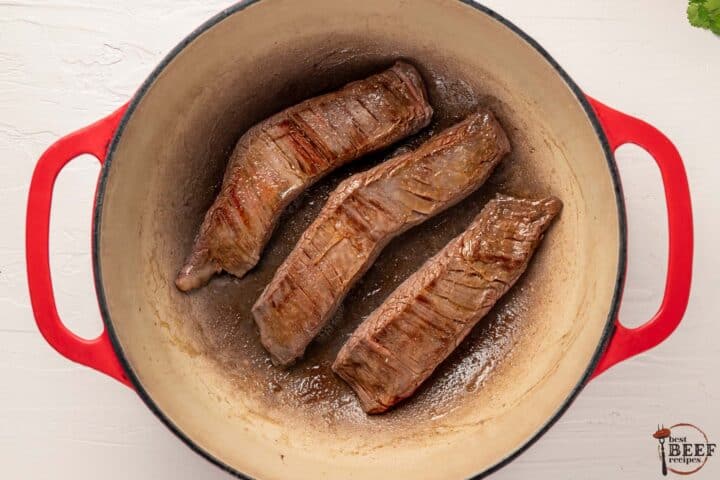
{"left": 175, "top": 62, "right": 432, "bottom": 291}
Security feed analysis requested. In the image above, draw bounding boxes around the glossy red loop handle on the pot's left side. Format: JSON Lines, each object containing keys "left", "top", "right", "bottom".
{"left": 25, "top": 105, "right": 132, "bottom": 387}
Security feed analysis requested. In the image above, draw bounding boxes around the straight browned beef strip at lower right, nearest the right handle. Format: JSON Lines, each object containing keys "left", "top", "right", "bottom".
{"left": 332, "top": 195, "right": 562, "bottom": 413}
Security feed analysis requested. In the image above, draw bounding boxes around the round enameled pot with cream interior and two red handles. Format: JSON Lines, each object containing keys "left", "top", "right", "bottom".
{"left": 27, "top": 0, "right": 693, "bottom": 479}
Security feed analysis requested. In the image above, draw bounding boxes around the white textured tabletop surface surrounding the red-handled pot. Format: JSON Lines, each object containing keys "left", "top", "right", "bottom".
{"left": 0, "top": 0, "right": 720, "bottom": 480}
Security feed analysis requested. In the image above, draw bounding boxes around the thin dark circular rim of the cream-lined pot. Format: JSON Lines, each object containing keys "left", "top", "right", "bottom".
{"left": 92, "top": 0, "right": 627, "bottom": 480}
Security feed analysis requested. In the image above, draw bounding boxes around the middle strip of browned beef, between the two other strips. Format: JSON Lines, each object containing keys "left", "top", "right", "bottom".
{"left": 252, "top": 111, "right": 510, "bottom": 365}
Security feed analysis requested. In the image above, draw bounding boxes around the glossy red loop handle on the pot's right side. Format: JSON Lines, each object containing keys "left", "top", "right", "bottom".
{"left": 588, "top": 97, "right": 693, "bottom": 378}
